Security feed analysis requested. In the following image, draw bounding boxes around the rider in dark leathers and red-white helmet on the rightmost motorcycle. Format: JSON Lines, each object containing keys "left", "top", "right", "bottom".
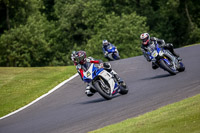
{"left": 140, "top": 33, "right": 182, "bottom": 69}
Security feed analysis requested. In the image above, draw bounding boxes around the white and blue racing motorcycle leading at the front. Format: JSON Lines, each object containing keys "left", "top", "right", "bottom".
{"left": 83, "top": 63, "right": 128, "bottom": 100}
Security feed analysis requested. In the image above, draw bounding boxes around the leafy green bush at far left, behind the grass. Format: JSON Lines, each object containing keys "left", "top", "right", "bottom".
{"left": 0, "top": 15, "right": 53, "bottom": 66}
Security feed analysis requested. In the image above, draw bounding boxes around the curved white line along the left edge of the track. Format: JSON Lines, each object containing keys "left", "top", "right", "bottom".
{"left": 0, "top": 73, "right": 78, "bottom": 120}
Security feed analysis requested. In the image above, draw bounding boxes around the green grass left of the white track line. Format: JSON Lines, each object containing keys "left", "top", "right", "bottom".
{"left": 0, "top": 66, "right": 76, "bottom": 117}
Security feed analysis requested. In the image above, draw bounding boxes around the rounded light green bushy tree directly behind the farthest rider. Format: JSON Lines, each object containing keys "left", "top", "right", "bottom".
{"left": 86, "top": 12, "right": 148, "bottom": 59}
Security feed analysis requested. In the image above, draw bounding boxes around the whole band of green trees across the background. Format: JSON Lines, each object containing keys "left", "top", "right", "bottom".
{"left": 0, "top": 0, "right": 200, "bottom": 67}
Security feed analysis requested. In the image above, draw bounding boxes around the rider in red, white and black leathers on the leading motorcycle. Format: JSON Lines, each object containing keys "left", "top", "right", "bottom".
{"left": 71, "top": 51, "right": 124, "bottom": 96}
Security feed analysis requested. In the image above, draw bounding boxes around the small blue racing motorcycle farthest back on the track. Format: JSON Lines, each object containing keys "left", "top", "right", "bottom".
{"left": 104, "top": 46, "right": 120, "bottom": 61}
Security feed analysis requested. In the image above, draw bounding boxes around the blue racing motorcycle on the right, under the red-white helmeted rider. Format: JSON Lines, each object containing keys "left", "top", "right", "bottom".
{"left": 147, "top": 43, "right": 185, "bottom": 75}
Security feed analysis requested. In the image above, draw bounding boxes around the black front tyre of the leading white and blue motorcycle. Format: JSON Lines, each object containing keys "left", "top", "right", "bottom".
{"left": 94, "top": 81, "right": 112, "bottom": 100}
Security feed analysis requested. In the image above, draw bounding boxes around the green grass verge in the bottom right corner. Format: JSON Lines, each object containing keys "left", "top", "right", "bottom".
{"left": 90, "top": 95, "right": 200, "bottom": 133}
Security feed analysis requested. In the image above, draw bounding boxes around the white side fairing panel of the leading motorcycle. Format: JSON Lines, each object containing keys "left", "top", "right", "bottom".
{"left": 99, "top": 70, "right": 115, "bottom": 93}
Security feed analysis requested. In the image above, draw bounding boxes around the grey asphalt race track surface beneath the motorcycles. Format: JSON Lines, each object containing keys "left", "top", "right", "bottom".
{"left": 0, "top": 45, "right": 200, "bottom": 133}
